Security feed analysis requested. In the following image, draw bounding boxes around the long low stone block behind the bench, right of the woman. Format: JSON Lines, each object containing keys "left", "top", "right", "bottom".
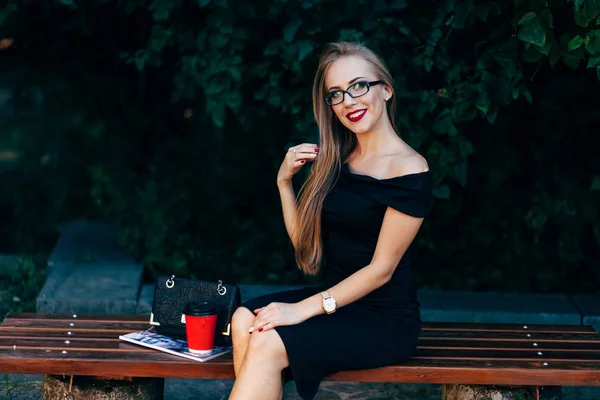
{"left": 418, "top": 290, "right": 581, "bottom": 325}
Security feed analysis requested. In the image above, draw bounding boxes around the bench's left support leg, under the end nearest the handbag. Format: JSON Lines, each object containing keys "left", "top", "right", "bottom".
{"left": 42, "top": 375, "right": 165, "bottom": 400}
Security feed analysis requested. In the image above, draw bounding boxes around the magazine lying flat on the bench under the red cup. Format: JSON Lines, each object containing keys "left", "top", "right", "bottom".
{"left": 119, "top": 327, "right": 233, "bottom": 362}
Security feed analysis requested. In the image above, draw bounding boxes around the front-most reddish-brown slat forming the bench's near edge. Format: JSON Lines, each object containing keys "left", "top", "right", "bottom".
{"left": 0, "top": 350, "right": 600, "bottom": 385}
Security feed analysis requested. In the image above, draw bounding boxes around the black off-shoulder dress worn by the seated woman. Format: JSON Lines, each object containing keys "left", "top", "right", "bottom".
{"left": 243, "top": 164, "right": 433, "bottom": 400}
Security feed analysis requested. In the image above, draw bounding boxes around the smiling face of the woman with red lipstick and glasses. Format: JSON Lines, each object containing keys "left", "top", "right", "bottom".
{"left": 325, "top": 56, "right": 391, "bottom": 134}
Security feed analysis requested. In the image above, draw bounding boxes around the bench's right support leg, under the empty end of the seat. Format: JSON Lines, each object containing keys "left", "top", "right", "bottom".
{"left": 442, "top": 384, "right": 562, "bottom": 400}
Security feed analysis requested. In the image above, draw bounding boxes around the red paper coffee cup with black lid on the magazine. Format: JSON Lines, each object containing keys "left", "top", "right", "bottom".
{"left": 183, "top": 302, "right": 217, "bottom": 354}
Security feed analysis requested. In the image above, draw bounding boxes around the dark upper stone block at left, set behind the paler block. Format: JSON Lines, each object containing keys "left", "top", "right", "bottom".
{"left": 48, "top": 220, "right": 135, "bottom": 271}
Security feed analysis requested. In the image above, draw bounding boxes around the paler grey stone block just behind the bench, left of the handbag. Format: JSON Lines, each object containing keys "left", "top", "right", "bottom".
{"left": 36, "top": 262, "right": 143, "bottom": 314}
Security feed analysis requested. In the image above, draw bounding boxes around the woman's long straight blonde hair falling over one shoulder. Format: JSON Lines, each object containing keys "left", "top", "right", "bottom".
{"left": 296, "top": 42, "right": 396, "bottom": 275}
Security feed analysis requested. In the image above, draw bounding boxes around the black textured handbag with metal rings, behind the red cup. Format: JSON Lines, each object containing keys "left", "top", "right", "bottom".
{"left": 150, "top": 275, "right": 241, "bottom": 346}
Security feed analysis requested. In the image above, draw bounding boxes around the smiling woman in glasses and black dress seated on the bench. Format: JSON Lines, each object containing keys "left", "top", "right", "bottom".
{"left": 230, "top": 43, "right": 432, "bottom": 400}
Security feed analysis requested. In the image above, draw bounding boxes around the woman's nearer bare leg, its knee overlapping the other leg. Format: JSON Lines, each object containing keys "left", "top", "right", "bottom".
{"left": 229, "top": 329, "right": 289, "bottom": 400}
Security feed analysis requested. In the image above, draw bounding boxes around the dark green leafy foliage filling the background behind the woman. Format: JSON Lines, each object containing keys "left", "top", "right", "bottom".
{"left": 0, "top": 0, "right": 600, "bottom": 291}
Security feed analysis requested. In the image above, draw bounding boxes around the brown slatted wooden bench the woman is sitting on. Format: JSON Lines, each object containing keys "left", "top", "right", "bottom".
{"left": 0, "top": 313, "right": 600, "bottom": 400}
